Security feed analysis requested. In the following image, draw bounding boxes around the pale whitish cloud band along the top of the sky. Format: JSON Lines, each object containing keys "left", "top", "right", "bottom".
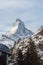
{"left": 0, "top": 0, "right": 36, "bottom": 9}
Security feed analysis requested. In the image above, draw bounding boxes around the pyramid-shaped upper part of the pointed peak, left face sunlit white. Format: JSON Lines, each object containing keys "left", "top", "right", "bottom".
{"left": 7, "top": 19, "right": 33, "bottom": 38}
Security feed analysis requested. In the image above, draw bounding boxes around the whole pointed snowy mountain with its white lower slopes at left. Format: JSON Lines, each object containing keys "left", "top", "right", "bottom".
{"left": 0, "top": 19, "right": 33, "bottom": 47}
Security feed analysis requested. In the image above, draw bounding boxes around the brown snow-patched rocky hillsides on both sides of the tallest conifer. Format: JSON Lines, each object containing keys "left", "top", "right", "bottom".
{"left": 12, "top": 27, "right": 43, "bottom": 60}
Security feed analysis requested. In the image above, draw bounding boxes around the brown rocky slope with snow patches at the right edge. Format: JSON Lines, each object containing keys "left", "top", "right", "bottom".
{"left": 32, "top": 26, "right": 43, "bottom": 60}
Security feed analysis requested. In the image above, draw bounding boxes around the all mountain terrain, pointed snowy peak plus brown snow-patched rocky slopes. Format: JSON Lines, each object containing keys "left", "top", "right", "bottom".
{"left": 0, "top": 19, "right": 43, "bottom": 64}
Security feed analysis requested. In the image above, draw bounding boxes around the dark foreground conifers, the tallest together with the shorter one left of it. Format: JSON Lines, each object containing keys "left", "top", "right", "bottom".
{"left": 16, "top": 38, "right": 41, "bottom": 65}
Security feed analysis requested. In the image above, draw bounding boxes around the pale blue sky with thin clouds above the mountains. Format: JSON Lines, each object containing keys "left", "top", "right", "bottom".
{"left": 0, "top": 0, "right": 43, "bottom": 33}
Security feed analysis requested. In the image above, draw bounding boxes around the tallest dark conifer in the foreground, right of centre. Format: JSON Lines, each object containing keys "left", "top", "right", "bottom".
{"left": 24, "top": 38, "right": 40, "bottom": 65}
